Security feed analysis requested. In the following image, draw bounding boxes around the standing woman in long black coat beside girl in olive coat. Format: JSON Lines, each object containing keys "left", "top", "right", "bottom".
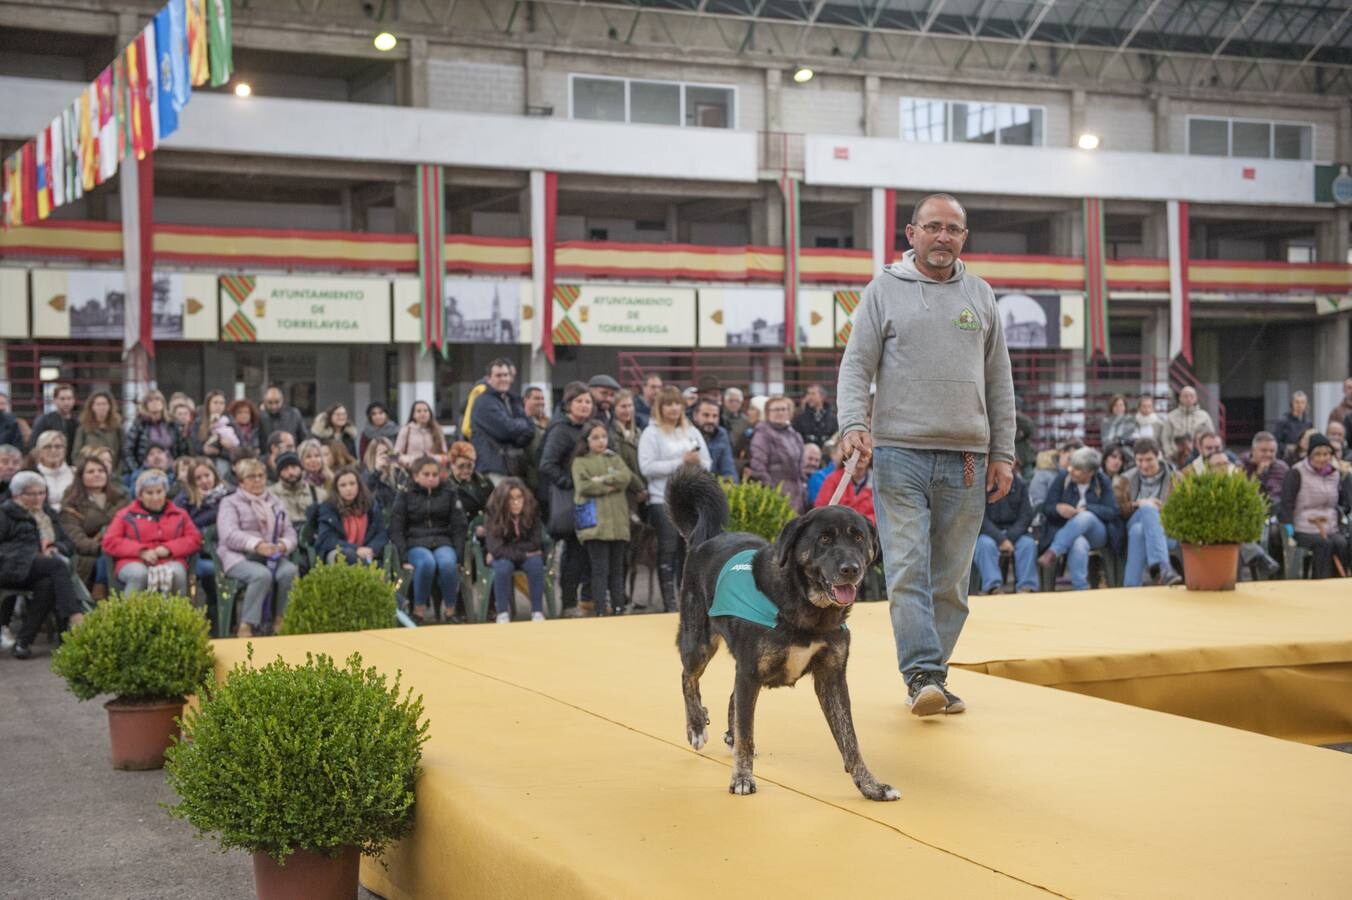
{"left": 539, "top": 381, "right": 594, "bottom": 619}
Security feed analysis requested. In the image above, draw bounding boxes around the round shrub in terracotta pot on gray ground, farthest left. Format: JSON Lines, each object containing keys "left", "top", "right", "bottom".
{"left": 51, "top": 592, "right": 214, "bottom": 769}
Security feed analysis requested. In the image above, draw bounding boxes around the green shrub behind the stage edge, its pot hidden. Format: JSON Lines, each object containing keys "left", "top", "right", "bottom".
{"left": 281, "top": 562, "right": 399, "bottom": 634}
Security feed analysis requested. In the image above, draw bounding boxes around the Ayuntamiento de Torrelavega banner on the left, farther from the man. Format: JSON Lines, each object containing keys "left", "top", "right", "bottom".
{"left": 220, "top": 274, "right": 391, "bottom": 343}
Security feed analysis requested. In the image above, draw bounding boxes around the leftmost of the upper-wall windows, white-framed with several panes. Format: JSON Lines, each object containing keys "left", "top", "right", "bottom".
{"left": 569, "top": 74, "right": 737, "bottom": 128}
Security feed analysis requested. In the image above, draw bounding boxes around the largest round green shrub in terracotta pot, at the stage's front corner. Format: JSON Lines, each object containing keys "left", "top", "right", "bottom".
{"left": 166, "top": 645, "right": 427, "bottom": 900}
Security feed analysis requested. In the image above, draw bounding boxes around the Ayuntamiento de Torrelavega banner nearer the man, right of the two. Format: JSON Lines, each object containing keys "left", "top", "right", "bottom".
{"left": 553, "top": 284, "right": 695, "bottom": 347}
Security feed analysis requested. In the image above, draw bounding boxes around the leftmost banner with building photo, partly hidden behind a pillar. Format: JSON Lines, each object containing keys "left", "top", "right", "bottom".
{"left": 32, "top": 269, "right": 216, "bottom": 341}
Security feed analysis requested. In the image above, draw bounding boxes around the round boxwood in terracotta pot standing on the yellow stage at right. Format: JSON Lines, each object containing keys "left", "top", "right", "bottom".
{"left": 1160, "top": 469, "right": 1268, "bottom": 591}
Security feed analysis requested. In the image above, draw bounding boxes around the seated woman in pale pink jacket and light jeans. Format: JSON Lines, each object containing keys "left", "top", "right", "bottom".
{"left": 216, "top": 459, "right": 299, "bottom": 638}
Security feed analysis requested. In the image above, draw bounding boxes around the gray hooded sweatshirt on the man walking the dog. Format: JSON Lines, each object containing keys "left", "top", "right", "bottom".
{"left": 836, "top": 250, "right": 1014, "bottom": 462}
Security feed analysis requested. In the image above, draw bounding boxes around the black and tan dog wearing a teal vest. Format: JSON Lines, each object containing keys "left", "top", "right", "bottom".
{"left": 667, "top": 466, "right": 900, "bottom": 800}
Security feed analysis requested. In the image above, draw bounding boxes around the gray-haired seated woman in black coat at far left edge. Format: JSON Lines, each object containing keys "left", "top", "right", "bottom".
{"left": 0, "top": 472, "right": 84, "bottom": 659}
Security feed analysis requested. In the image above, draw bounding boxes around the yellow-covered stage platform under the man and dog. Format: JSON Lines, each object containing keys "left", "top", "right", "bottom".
{"left": 216, "top": 585, "right": 1352, "bottom": 899}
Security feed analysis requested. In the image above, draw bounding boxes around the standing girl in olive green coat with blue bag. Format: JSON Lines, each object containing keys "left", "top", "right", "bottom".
{"left": 572, "top": 419, "right": 633, "bottom": 616}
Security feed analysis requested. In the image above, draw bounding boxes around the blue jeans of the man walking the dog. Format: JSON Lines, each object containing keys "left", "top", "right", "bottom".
{"left": 873, "top": 447, "right": 986, "bottom": 682}
